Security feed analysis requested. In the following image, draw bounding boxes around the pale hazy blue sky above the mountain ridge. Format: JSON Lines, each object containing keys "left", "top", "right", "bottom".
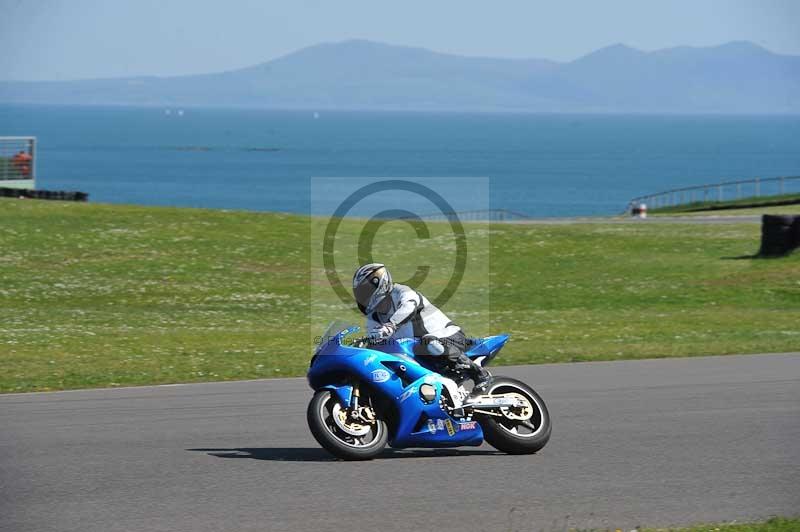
{"left": 0, "top": 0, "right": 800, "bottom": 80}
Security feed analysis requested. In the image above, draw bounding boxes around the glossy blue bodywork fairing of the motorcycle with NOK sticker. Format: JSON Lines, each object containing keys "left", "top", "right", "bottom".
{"left": 308, "top": 328, "right": 500, "bottom": 447}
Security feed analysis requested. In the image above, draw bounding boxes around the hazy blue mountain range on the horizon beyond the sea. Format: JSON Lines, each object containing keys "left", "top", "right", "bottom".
{"left": 0, "top": 40, "right": 800, "bottom": 113}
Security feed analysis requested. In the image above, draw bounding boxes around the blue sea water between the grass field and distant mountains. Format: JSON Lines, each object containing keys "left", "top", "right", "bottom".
{"left": 0, "top": 105, "right": 800, "bottom": 217}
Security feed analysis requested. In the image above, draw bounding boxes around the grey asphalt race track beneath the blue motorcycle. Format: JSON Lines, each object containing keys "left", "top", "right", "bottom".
{"left": 0, "top": 354, "right": 800, "bottom": 532}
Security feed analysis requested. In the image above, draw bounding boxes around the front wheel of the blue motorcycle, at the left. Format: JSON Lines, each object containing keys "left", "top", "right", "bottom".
{"left": 306, "top": 390, "right": 388, "bottom": 460}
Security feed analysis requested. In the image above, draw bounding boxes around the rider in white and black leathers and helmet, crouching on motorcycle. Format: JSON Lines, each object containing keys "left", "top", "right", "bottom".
{"left": 353, "top": 263, "right": 490, "bottom": 390}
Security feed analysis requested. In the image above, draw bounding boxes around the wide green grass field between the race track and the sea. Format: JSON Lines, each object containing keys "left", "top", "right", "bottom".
{"left": 0, "top": 199, "right": 800, "bottom": 392}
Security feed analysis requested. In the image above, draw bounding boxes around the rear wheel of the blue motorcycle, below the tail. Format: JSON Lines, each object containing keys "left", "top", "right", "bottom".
{"left": 479, "top": 377, "right": 551, "bottom": 454}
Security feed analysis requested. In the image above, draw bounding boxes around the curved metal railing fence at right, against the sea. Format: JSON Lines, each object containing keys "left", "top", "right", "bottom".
{"left": 628, "top": 176, "right": 800, "bottom": 212}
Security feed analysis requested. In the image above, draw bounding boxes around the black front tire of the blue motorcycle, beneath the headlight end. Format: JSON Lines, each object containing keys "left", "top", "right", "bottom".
{"left": 306, "top": 390, "right": 388, "bottom": 460}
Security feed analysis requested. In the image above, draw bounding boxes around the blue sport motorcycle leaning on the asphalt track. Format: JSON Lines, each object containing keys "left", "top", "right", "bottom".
{"left": 307, "top": 323, "right": 550, "bottom": 460}
